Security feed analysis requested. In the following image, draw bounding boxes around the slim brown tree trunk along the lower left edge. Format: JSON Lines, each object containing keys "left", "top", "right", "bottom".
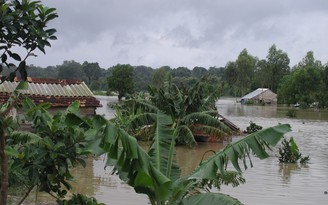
{"left": 0, "top": 125, "right": 8, "bottom": 205}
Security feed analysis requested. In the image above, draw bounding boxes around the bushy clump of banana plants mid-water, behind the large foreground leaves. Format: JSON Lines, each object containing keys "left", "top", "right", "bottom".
{"left": 112, "top": 74, "right": 228, "bottom": 146}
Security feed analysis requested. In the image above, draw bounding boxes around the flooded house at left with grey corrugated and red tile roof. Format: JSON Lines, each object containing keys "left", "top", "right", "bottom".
{"left": 0, "top": 78, "right": 102, "bottom": 116}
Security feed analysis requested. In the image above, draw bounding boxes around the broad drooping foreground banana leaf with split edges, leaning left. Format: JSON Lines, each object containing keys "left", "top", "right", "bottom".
{"left": 86, "top": 116, "right": 172, "bottom": 200}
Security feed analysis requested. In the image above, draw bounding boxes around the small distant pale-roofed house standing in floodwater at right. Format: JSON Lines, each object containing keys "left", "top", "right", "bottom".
{"left": 240, "top": 88, "right": 277, "bottom": 104}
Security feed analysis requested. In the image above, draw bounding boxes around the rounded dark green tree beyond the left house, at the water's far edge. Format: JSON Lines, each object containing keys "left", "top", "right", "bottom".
{"left": 107, "top": 64, "right": 135, "bottom": 101}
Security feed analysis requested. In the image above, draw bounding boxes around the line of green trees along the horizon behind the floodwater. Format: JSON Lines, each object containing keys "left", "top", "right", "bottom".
{"left": 10, "top": 44, "right": 328, "bottom": 108}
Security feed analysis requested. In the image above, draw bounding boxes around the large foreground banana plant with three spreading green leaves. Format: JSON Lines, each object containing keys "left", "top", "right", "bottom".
{"left": 86, "top": 112, "right": 290, "bottom": 205}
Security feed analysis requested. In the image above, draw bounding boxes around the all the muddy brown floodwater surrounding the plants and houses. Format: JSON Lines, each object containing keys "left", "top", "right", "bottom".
{"left": 19, "top": 97, "right": 328, "bottom": 205}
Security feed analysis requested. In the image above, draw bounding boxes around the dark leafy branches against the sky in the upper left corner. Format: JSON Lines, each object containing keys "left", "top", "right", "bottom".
{"left": 0, "top": 0, "right": 57, "bottom": 81}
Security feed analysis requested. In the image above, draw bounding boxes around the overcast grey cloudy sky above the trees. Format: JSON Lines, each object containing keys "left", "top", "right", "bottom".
{"left": 28, "top": 0, "right": 328, "bottom": 69}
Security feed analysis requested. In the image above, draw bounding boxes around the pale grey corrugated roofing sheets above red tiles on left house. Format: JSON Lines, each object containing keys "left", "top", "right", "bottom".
{"left": 0, "top": 81, "right": 93, "bottom": 97}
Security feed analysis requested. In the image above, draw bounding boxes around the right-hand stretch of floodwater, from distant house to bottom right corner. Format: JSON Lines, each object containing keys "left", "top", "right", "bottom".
{"left": 217, "top": 99, "right": 328, "bottom": 205}
